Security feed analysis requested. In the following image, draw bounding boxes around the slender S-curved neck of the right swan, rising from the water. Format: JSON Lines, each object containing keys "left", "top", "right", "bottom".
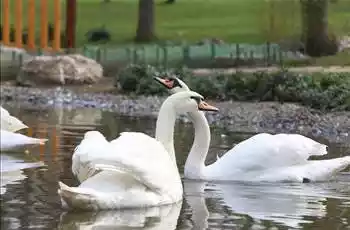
{"left": 185, "top": 111, "right": 210, "bottom": 179}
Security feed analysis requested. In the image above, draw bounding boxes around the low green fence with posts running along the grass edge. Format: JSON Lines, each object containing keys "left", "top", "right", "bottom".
{"left": 82, "top": 43, "right": 302, "bottom": 67}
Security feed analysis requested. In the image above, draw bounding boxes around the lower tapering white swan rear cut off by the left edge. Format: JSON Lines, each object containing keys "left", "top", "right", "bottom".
{"left": 0, "top": 130, "right": 47, "bottom": 151}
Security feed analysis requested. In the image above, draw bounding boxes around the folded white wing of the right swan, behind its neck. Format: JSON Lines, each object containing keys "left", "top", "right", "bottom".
{"left": 209, "top": 133, "right": 327, "bottom": 174}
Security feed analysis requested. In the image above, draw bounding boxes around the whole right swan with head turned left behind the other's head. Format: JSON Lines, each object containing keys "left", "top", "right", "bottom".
{"left": 154, "top": 77, "right": 350, "bottom": 182}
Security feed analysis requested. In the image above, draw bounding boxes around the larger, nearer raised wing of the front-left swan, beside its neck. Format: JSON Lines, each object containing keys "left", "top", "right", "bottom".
{"left": 98, "top": 132, "right": 182, "bottom": 194}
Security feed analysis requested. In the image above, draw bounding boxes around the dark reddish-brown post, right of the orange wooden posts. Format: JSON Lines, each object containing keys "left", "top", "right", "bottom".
{"left": 66, "top": 0, "right": 77, "bottom": 49}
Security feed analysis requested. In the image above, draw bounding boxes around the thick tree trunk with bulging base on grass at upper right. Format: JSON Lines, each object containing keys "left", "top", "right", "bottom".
{"left": 300, "top": 0, "right": 338, "bottom": 57}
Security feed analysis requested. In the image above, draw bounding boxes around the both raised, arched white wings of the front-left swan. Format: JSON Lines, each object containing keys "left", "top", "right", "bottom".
{"left": 72, "top": 131, "right": 182, "bottom": 198}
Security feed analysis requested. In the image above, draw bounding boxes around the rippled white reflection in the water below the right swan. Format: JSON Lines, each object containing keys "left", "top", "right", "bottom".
{"left": 184, "top": 181, "right": 350, "bottom": 229}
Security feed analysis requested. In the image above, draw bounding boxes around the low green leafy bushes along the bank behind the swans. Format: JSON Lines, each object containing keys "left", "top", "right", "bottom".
{"left": 116, "top": 65, "right": 350, "bottom": 111}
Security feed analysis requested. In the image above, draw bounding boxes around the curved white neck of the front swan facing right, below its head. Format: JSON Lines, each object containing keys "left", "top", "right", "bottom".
{"left": 156, "top": 100, "right": 176, "bottom": 163}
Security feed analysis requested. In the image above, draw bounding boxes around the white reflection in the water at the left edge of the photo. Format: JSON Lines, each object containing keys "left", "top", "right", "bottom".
{"left": 0, "top": 152, "right": 44, "bottom": 195}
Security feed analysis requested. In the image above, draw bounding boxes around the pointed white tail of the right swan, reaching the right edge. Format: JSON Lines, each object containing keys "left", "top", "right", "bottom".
{"left": 304, "top": 156, "right": 350, "bottom": 181}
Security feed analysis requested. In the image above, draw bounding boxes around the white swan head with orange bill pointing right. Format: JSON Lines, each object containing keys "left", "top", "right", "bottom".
{"left": 166, "top": 91, "right": 219, "bottom": 113}
